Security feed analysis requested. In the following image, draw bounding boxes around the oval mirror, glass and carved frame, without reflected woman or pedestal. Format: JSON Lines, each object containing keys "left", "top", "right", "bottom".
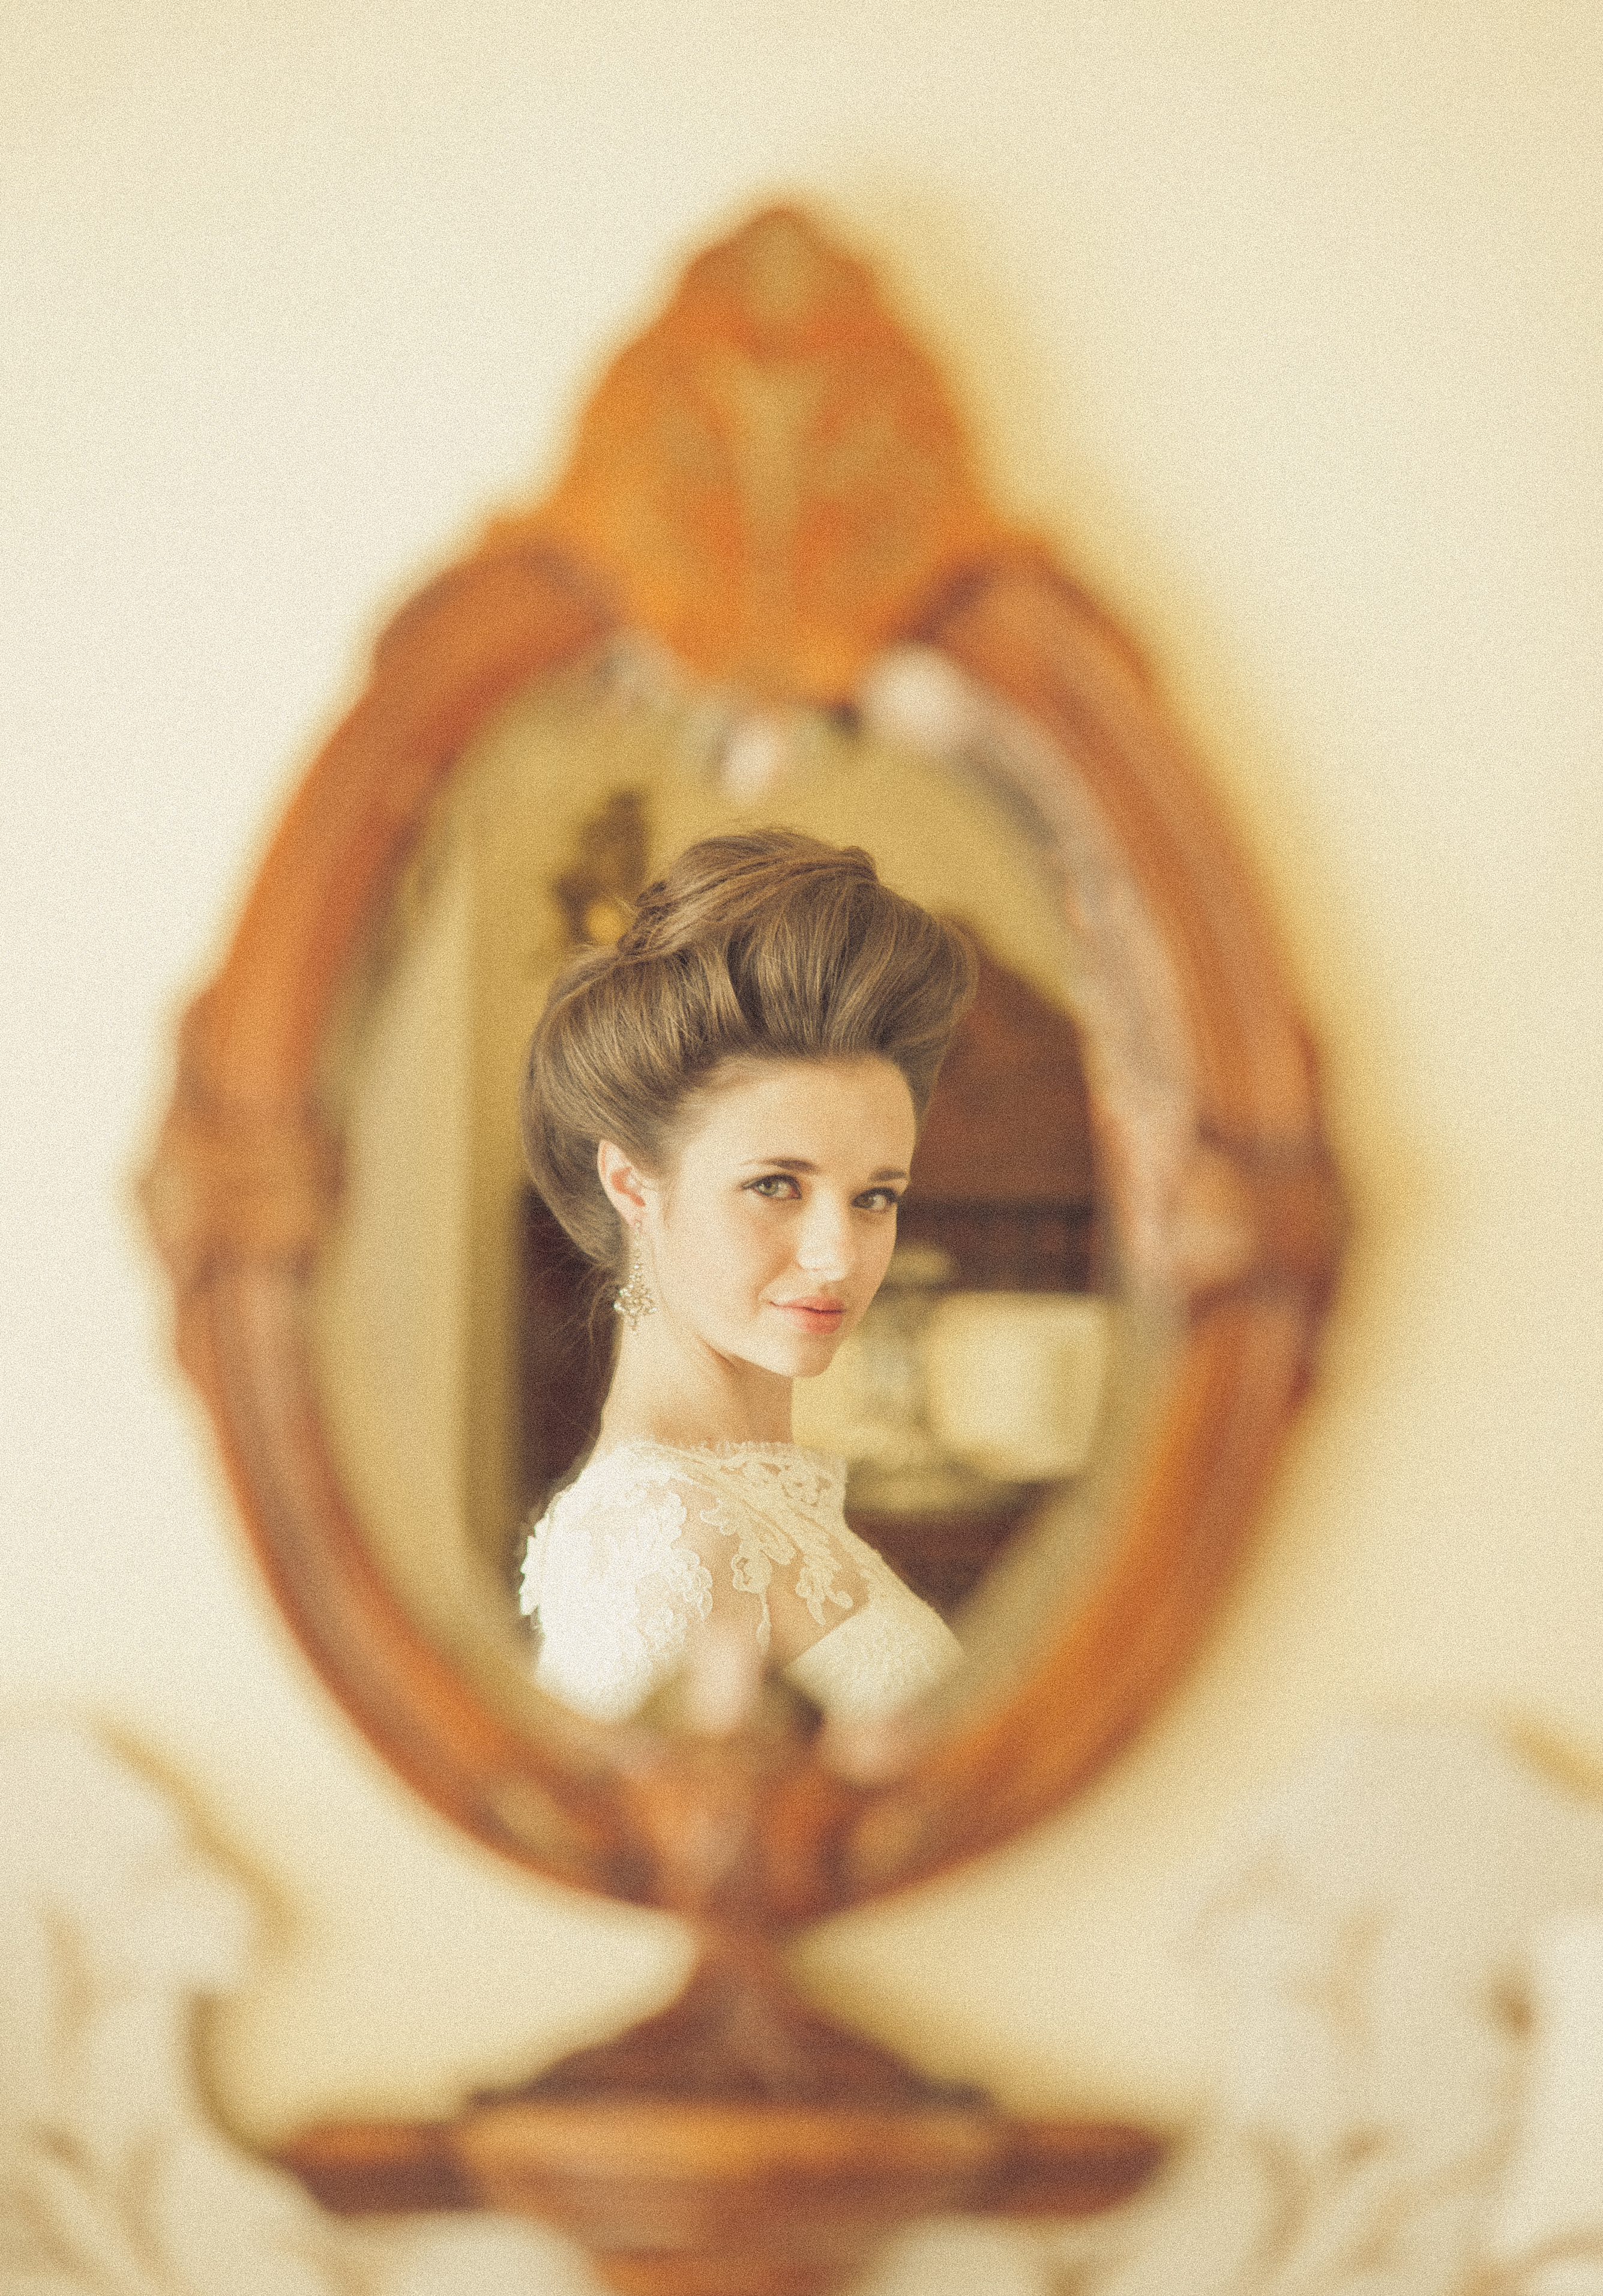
{"left": 147, "top": 209, "right": 1339, "bottom": 1920}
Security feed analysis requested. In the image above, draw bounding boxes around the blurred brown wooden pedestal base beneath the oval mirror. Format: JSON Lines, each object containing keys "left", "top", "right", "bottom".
{"left": 283, "top": 1940, "right": 1162, "bottom": 2296}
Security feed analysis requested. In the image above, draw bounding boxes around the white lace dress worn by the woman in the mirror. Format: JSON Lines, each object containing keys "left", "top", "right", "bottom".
{"left": 522, "top": 1442, "right": 960, "bottom": 1720}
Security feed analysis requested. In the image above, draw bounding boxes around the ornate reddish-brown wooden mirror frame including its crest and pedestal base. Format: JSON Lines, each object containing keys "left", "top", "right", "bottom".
{"left": 145, "top": 209, "right": 1341, "bottom": 2291}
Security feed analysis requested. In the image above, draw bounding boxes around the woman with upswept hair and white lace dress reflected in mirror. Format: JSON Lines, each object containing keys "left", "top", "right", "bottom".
{"left": 523, "top": 829, "right": 973, "bottom": 1715}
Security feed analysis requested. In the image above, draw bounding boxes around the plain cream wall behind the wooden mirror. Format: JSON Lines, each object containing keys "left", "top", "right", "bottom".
{"left": 0, "top": 0, "right": 1603, "bottom": 2133}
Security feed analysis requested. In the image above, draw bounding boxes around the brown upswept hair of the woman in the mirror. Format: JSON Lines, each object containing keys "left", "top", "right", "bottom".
{"left": 523, "top": 829, "right": 976, "bottom": 1267}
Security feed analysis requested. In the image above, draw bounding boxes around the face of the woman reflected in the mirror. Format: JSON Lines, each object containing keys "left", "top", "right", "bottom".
{"left": 643, "top": 1056, "right": 914, "bottom": 1380}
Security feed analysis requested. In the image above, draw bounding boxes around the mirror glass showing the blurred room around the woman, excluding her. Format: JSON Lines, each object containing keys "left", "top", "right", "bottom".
{"left": 312, "top": 640, "right": 1139, "bottom": 1715}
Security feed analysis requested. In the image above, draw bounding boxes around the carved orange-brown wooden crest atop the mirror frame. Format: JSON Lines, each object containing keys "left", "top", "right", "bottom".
{"left": 492, "top": 206, "right": 1008, "bottom": 702}
